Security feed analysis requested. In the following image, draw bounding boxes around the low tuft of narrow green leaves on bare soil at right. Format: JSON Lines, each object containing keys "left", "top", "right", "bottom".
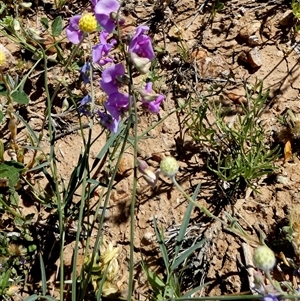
{"left": 187, "top": 83, "right": 279, "bottom": 186}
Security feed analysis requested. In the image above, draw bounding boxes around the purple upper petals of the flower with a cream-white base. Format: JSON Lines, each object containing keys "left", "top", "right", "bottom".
{"left": 129, "top": 25, "right": 154, "bottom": 61}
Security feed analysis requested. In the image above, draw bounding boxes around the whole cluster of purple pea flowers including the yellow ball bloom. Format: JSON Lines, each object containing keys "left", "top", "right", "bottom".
{"left": 66, "top": 0, "right": 164, "bottom": 133}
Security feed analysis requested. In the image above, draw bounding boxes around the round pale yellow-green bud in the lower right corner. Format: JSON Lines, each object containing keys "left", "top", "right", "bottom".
{"left": 253, "top": 246, "right": 276, "bottom": 272}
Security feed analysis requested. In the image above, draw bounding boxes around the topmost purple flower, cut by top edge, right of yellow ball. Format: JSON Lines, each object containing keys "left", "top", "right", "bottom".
{"left": 94, "top": 0, "right": 120, "bottom": 33}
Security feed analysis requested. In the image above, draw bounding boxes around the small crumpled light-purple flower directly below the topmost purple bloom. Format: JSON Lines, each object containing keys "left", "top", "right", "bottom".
{"left": 92, "top": 30, "right": 117, "bottom": 66}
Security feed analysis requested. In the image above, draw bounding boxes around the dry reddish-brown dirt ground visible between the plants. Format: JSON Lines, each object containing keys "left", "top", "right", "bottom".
{"left": 3, "top": 0, "right": 300, "bottom": 300}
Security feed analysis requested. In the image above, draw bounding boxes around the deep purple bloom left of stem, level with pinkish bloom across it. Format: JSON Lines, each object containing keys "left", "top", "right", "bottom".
{"left": 104, "top": 92, "right": 129, "bottom": 120}
